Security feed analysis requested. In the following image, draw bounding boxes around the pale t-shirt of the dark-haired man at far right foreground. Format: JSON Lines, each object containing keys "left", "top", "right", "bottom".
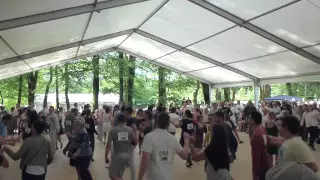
{"left": 278, "top": 137, "right": 315, "bottom": 164}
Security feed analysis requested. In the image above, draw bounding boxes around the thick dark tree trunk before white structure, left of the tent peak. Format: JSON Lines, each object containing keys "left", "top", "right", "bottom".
{"left": 92, "top": 55, "right": 100, "bottom": 111}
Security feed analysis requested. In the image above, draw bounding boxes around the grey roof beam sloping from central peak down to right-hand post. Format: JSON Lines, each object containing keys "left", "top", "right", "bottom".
{"left": 136, "top": 29, "right": 258, "bottom": 81}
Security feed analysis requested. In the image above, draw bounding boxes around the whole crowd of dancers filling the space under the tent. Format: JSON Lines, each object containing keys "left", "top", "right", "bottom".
{"left": 0, "top": 100, "right": 320, "bottom": 180}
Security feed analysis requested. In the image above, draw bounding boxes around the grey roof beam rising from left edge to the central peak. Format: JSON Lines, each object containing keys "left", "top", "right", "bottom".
{"left": 0, "top": 29, "right": 133, "bottom": 65}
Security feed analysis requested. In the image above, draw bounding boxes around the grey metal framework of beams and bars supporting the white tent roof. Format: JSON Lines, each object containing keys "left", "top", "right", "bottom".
{"left": 0, "top": 0, "right": 320, "bottom": 87}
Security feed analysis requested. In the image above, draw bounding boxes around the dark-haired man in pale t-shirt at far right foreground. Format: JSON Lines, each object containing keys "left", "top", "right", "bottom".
{"left": 278, "top": 116, "right": 319, "bottom": 175}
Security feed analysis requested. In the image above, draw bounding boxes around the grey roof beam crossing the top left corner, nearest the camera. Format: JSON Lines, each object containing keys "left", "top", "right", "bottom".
{"left": 0, "top": 0, "right": 150, "bottom": 31}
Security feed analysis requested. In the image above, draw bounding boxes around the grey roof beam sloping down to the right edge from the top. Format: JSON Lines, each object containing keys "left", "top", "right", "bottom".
{"left": 189, "top": 0, "right": 320, "bottom": 64}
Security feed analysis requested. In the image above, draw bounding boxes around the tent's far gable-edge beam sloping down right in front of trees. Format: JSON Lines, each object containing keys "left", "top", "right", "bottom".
{"left": 115, "top": 48, "right": 212, "bottom": 85}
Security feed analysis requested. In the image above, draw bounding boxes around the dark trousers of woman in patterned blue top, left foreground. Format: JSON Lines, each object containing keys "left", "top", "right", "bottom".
{"left": 75, "top": 157, "right": 92, "bottom": 180}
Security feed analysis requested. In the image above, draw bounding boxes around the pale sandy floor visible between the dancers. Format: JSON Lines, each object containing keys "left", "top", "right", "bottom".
{"left": 0, "top": 130, "right": 320, "bottom": 180}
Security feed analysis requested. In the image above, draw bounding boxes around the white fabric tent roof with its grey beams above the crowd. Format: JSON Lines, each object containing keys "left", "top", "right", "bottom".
{"left": 0, "top": 0, "right": 320, "bottom": 87}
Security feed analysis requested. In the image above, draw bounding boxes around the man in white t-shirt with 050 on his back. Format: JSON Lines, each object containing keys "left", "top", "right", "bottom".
{"left": 138, "top": 112, "right": 190, "bottom": 180}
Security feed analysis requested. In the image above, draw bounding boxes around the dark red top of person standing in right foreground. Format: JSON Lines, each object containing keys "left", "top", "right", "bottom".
{"left": 251, "top": 127, "right": 271, "bottom": 177}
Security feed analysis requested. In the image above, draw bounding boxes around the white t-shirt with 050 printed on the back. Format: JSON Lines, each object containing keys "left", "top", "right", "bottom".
{"left": 142, "top": 129, "right": 183, "bottom": 180}
